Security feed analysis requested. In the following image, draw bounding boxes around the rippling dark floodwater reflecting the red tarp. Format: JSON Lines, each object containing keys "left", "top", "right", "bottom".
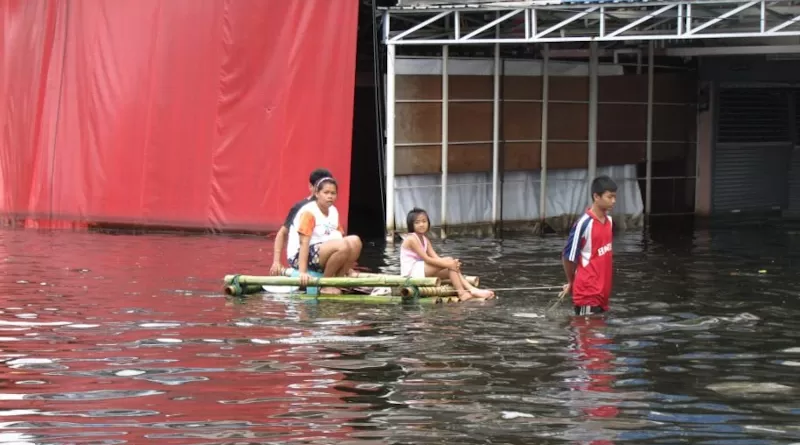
{"left": 0, "top": 221, "right": 800, "bottom": 445}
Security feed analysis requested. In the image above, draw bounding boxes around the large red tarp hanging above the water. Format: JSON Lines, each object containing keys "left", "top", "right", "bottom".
{"left": 0, "top": 0, "right": 358, "bottom": 230}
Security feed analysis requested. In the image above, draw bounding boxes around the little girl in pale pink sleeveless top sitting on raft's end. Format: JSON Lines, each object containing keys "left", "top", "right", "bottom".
{"left": 400, "top": 207, "right": 494, "bottom": 301}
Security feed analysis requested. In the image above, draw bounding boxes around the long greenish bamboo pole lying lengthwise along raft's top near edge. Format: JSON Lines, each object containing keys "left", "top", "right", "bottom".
{"left": 223, "top": 275, "right": 441, "bottom": 287}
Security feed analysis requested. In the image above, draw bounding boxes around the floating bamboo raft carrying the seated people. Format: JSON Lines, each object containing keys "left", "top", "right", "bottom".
{"left": 223, "top": 268, "right": 480, "bottom": 304}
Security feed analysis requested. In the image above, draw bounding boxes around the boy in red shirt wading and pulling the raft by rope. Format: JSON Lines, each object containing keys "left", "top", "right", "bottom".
{"left": 562, "top": 176, "right": 617, "bottom": 315}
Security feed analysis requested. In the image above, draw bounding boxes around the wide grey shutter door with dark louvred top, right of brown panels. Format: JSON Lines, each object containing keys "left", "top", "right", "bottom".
{"left": 712, "top": 88, "right": 792, "bottom": 213}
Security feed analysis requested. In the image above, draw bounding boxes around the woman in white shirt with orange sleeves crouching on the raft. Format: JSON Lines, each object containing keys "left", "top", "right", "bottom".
{"left": 287, "top": 178, "right": 361, "bottom": 294}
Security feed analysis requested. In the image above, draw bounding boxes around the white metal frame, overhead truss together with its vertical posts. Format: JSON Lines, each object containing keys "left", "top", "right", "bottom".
{"left": 382, "top": 0, "right": 800, "bottom": 240}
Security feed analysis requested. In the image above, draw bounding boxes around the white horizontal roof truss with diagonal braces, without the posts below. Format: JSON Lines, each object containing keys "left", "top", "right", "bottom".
{"left": 384, "top": 0, "right": 800, "bottom": 45}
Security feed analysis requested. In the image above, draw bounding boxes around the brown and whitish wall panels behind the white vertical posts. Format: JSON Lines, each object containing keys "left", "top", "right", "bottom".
{"left": 395, "top": 58, "right": 697, "bottom": 230}
